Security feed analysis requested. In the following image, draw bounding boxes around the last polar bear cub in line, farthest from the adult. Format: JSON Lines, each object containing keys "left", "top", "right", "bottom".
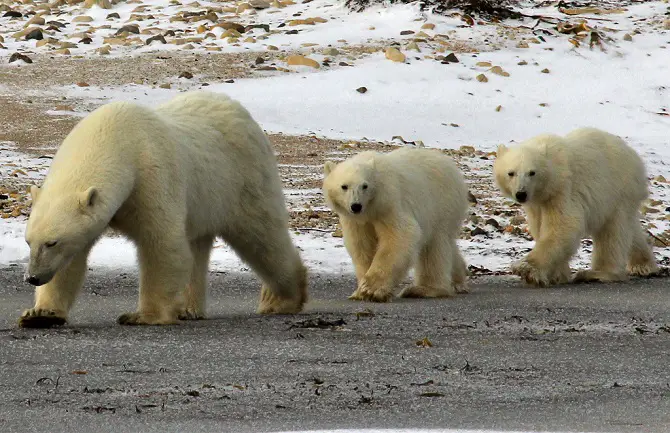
{"left": 493, "top": 128, "right": 657, "bottom": 286}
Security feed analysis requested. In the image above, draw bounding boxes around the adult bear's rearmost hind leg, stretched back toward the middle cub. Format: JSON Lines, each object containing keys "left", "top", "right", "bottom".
{"left": 222, "top": 214, "right": 307, "bottom": 314}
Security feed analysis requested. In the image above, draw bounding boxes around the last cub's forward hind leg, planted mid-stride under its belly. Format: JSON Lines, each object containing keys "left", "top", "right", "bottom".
{"left": 573, "top": 213, "right": 633, "bottom": 283}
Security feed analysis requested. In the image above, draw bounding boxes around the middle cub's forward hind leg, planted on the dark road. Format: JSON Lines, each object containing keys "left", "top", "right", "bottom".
{"left": 400, "top": 235, "right": 456, "bottom": 298}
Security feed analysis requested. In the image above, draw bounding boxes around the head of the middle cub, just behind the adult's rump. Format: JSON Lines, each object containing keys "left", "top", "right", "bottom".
{"left": 323, "top": 152, "right": 376, "bottom": 218}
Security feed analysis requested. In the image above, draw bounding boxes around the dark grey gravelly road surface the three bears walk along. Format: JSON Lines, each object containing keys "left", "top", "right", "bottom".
{"left": 0, "top": 267, "right": 670, "bottom": 433}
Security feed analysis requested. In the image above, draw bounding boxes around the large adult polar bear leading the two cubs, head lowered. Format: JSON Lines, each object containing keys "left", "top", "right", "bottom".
{"left": 19, "top": 92, "right": 307, "bottom": 327}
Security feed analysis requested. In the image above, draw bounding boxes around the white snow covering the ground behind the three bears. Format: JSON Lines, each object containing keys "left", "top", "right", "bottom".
{"left": 0, "top": 0, "right": 670, "bottom": 272}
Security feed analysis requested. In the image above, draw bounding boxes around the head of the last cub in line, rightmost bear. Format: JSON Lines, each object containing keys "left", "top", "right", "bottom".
{"left": 493, "top": 137, "right": 558, "bottom": 204}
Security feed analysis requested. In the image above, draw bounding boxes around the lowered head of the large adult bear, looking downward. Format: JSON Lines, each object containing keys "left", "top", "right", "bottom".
{"left": 25, "top": 185, "right": 105, "bottom": 286}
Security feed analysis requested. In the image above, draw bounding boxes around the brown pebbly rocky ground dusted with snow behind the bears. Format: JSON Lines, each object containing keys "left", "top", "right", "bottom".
{"left": 0, "top": 0, "right": 670, "bottom": 271}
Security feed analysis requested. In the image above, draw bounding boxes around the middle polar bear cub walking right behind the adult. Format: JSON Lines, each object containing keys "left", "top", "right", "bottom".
{"left": 323, "top": 148, "right": 468, "bottom": 302}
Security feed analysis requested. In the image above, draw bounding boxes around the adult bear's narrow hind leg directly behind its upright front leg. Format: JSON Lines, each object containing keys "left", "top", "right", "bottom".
{"left": 179, "top": 236, "right": 214, "bottom": 320}
